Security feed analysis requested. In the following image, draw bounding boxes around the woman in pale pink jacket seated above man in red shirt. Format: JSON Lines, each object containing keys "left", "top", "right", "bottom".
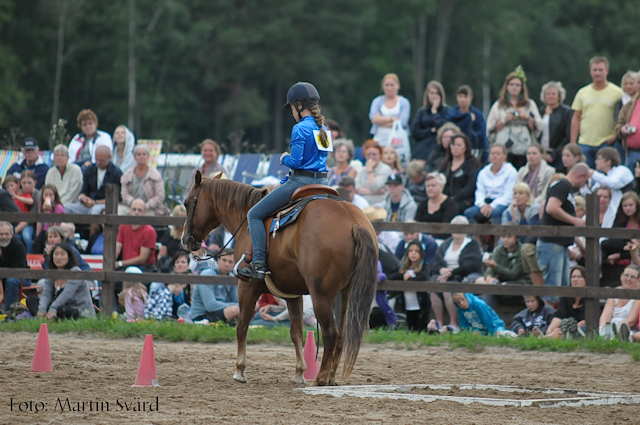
{"left": 118, "top": 144, "right": 169, "bottom": 216}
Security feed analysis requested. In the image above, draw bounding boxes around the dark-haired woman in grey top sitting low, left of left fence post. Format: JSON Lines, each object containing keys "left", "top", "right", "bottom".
{"left": 38, "top": 242, "right": 95, "bottom": 319}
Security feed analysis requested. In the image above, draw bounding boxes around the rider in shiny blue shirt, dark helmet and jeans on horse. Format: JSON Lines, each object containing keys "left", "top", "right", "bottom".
{"left": 238, "top": 82, "right": 333, "bottom": 279}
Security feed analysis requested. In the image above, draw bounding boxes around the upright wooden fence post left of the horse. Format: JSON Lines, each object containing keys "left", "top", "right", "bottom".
{"left": 100, "top": 183, "right": 119, "bottom": 318}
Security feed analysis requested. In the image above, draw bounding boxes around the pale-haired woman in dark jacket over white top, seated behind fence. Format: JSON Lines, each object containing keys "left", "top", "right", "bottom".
{"left": 429, "top": 215, "right": 482, "bottom": 333}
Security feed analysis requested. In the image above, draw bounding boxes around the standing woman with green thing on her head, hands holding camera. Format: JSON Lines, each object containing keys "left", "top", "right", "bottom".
{"left": 487, "top": 66, "right": 542, "bottom": 168}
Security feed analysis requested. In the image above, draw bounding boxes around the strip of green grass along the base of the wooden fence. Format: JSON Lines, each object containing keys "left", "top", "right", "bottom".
{"left": 0, "top": 318, "right": 640, "bottom": 361}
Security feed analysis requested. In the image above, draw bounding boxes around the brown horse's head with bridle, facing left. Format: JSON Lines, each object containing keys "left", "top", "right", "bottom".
{"left": 182, "top": 171, "right": 220, "bottom": 251}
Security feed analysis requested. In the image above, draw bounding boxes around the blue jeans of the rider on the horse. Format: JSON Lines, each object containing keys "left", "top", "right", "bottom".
{"left": 247, "top": 176, "right": 329, "bottom": 263}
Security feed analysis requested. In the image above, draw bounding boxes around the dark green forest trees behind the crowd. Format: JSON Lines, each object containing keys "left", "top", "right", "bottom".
{"left": 0, "top": 0, "right": 640, "bottom": 152}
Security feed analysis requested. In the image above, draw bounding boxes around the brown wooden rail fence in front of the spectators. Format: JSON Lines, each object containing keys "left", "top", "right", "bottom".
{"left": 0, "top": 184, "right": 640, "bottom": 333}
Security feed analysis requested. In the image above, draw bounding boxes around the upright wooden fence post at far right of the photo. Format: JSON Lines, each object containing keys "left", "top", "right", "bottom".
{"left": 582, "top": 194, "right": 600, "bottom": 335}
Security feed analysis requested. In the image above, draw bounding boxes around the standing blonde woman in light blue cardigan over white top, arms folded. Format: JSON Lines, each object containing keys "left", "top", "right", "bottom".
{"left": 369, "top": 73, "right": 411, "bottom": 145}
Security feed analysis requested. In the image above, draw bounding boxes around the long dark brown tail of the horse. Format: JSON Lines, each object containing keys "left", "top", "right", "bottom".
{"left": 340, "top": 224, "right": 378, "bottom": 380}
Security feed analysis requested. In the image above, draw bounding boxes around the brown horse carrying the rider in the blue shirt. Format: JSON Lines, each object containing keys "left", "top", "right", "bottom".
{"left": 182, "top": 172, "right": 378, "bottom": 385}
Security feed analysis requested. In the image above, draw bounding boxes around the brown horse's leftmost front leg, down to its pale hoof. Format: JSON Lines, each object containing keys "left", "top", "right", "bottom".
{"left": 233, "top": 281, "right": 263, "bottom": 383}
